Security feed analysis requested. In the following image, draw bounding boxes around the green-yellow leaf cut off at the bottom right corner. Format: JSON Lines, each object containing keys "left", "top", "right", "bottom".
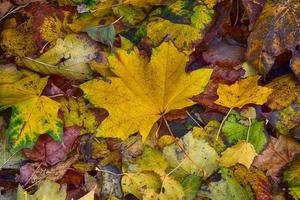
{"left": 283, "top": 157, "right": 300, "bottom": 199}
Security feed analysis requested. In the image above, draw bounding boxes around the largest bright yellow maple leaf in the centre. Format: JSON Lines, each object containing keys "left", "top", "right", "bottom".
{"left": 80, "top": 42, "right": 212, "bottom": 140}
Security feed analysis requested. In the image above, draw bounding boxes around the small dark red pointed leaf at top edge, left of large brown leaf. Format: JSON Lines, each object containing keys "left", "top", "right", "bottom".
{"left": 242, "top": 0, "right": 266, "bottom": 28}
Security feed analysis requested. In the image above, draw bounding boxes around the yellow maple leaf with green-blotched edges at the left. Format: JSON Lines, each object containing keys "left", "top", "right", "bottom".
{"left": 0, "top": 74, "right": 63, "bottom": 151}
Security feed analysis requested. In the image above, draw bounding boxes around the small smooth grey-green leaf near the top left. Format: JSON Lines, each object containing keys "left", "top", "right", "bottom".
{"left": 84, "top": 24, "right": 116, "bottom": 46}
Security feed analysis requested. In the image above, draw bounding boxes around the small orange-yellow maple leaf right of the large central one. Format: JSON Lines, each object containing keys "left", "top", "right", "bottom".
{"left": 215, "top": 76, "right": 272, "bottom": 108}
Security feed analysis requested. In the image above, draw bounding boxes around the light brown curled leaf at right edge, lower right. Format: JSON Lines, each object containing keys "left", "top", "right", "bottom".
{"left": 253, "top": 136, "right": 300, "bottom": 180}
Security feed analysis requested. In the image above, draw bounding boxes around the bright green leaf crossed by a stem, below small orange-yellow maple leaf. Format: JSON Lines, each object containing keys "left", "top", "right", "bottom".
{"left": 222, "top": 110, "right": 268, "bottom": 153}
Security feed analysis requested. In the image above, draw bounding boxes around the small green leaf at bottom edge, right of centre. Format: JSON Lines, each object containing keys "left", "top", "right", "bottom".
{"left": 182, "top": 175, "right": 201, "bottom": 200}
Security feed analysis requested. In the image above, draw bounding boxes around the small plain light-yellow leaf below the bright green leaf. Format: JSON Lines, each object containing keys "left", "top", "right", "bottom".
{"left": 219, "top": 140, "right": 256, "bottom": 169}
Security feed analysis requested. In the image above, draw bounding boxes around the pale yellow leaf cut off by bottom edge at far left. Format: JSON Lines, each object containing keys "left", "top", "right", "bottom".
{"left": 17, "top": 180, "right": 67, "bottom": 200}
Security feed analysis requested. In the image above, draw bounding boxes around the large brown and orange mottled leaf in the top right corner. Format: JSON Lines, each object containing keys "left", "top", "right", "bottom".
{"left": 247, "top": 0, "right": 300, "bottom": 75}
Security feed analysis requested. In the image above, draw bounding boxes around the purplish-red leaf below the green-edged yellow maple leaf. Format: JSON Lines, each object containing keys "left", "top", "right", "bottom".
{"left": 24, "top": 126, "right": 80, "bottom": 165}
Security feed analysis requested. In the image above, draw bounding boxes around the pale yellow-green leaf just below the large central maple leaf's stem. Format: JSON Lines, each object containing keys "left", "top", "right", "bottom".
{"left": 163, "top": 132, "right": 219, "bottom": 177}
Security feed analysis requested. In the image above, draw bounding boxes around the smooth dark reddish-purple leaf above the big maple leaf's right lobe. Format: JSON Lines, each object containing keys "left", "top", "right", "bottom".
{"left": 202, "top": 41, "right": 246, "bottom": 67}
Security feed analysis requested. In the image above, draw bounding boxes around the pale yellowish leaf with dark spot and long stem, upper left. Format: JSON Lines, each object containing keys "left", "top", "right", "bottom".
{"left": 22, "top": 34, "right": 99, "bottom": 79}
